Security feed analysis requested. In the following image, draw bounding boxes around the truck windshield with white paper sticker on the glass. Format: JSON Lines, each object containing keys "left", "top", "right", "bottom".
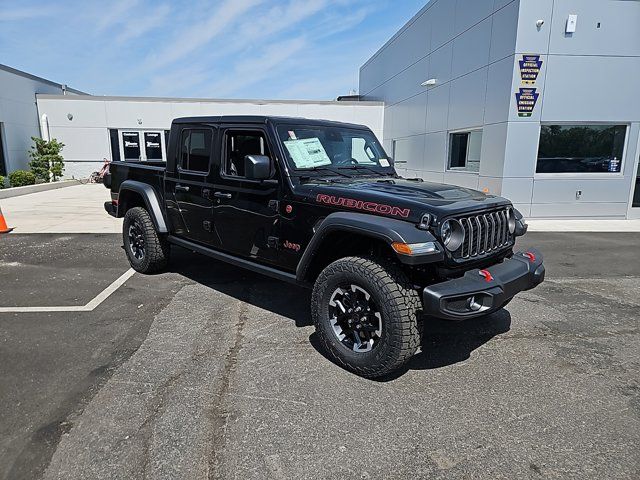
{"left": 277, "top": 125, "right": 392, "bottom": 173}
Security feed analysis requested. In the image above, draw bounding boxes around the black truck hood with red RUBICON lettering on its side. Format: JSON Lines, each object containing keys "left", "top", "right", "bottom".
{"left": 295, "top": 178, "right": 509, "bottom": 221}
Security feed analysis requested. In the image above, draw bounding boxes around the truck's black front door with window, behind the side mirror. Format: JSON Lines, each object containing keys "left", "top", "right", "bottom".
{"left": 213, "top": 127, "right": 280, "bottom": 263}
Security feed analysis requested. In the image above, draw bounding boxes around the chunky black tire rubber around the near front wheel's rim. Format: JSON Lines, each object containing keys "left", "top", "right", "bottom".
{"left": 311, "top": 256, "right": 422, "bottom": 378}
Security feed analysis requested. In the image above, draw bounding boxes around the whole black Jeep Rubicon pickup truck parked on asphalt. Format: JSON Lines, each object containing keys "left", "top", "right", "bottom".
{"left": 105, "top": 116, "right": 544, "bottom": 378}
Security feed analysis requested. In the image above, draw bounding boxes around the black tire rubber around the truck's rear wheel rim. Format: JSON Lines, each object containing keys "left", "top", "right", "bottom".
{"left": 122, "top": 207, "right": 170, "bottom": 273}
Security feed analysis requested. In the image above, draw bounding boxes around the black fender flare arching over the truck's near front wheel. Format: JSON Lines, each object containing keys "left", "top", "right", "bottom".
{"left": 296, "top": 212, "right": 444, "bottom": 281}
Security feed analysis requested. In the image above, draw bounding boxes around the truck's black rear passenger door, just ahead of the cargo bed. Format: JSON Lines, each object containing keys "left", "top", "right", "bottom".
{"left": 165, "top": 126, "right": 218, "bottom": 246}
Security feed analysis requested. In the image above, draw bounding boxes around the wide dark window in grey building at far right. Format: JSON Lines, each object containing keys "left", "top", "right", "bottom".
{"left": 536, "top": 125, "right": 627, "bottom": 173}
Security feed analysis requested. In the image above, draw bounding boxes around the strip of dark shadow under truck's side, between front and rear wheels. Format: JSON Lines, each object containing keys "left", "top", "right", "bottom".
{"left": 168, "top": 248, "right": 312, "bottom": 327}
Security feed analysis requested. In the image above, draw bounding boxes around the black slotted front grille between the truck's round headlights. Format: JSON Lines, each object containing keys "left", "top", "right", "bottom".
{"left": 453, "top": 208, "right": 513, "bottom": 259}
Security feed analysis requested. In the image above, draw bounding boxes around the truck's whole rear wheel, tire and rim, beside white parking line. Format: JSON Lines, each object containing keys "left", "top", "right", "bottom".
{"left": 122, "top": 207, "right": 169, "bottom": 273}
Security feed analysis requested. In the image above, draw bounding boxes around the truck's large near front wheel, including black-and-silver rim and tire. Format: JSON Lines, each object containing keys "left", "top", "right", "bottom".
{"left": 311, "top": 257, "right": 421, "bottom": 378}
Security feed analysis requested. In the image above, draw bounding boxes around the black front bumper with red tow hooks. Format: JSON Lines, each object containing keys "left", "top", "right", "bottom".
{"left": 422, "top": 249, "right": 544, "bottom": 320}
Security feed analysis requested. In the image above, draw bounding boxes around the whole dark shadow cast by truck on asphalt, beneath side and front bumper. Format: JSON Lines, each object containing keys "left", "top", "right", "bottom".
{"left": 169, "top": 248, "right": 511, "bottom": 381}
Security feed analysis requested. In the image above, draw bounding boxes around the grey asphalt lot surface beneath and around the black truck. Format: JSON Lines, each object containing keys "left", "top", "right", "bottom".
{"left": 0, "top": 232, "right": 640, "bottom": 479}
